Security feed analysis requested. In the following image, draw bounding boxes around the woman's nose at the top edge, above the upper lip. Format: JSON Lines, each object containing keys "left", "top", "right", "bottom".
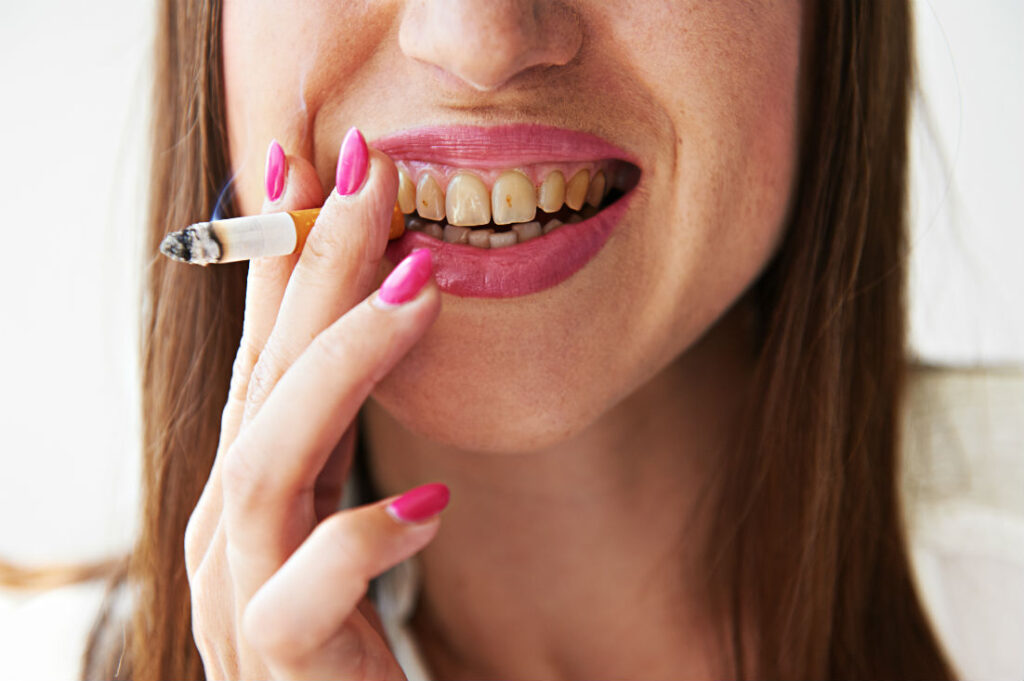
{"left": 398, "top": 0, "right": 583, "bottom": 92}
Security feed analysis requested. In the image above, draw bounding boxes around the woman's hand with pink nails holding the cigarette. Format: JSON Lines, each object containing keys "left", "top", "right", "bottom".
{"left": 185, "top": 133, "right": 447, "bottom": 679}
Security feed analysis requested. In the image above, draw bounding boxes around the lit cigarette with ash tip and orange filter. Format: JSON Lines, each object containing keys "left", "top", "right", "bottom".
{"left": 160, "top": 205, "right": 406, "bottom": 265}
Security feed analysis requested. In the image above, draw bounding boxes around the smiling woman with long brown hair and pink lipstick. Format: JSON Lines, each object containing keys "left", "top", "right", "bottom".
{"left": 83, "top": 0, "right": 951, "bottom": 679}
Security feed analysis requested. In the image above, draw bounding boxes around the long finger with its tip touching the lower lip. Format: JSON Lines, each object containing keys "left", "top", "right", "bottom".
{"left": 223, "top": 251, "right": 440, "bottom": 603}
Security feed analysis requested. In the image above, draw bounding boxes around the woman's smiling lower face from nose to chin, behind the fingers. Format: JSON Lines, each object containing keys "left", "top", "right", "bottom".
{"left": 223, "top": 0, "right": 802, "bottom": 451}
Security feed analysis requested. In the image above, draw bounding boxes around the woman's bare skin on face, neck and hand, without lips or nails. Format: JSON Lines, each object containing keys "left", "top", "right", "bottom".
{"left": 186, "top": 0, "right": 802, "bottom": 678}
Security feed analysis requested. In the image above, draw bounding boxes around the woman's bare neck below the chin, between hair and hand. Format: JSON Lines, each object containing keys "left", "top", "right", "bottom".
{"left": 364, "top": 305, "right": 749, "bottom": 679}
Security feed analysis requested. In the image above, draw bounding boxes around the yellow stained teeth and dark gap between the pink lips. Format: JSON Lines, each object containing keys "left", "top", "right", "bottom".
{"left": 398, "top": 159, "right": 640, "bottom": 249}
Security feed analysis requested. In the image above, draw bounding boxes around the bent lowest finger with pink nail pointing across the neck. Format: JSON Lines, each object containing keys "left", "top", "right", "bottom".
{"left": 243, "top": 483, "right": 449, "bottom": 679}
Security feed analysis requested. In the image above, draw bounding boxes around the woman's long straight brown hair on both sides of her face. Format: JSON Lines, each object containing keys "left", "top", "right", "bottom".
{"left": 79, "top": 0, "right": 951, "bottom": 681}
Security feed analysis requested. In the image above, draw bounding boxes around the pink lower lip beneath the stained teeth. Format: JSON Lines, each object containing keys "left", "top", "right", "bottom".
{"left": 387, "top": 191, "right": 633, "bottom": 298}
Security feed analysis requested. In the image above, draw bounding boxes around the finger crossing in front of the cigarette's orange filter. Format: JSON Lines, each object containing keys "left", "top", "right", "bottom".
{"left": 244, "top": 133, "right": 398, "bottom": 421}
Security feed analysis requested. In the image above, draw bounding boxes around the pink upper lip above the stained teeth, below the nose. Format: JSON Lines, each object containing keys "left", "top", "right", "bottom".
{"left": 371, "top": 124, "right": 639, "bottom": 169}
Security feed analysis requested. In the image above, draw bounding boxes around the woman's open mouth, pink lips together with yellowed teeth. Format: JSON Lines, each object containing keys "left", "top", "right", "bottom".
{"left": 373, "top": 125, "right": 641, "bottom": 298}
